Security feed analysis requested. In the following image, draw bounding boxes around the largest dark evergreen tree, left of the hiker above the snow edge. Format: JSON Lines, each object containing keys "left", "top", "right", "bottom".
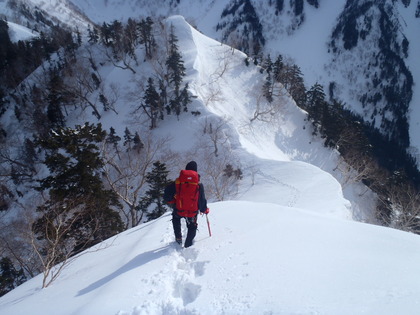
{"left": 33, "top": 123, "right": 124, "bottom": 263}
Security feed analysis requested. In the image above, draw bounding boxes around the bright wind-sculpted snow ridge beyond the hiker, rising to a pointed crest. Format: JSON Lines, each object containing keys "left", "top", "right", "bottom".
{"left": 166, "top": 16, "right": 351, "bottom": 218}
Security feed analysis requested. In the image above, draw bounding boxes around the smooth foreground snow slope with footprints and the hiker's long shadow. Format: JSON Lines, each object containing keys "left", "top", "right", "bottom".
{"left": 0, "top": 202, "right": 420, "bottom": 315}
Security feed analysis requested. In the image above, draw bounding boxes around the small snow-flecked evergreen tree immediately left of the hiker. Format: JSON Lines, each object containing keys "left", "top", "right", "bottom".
{"left": 139, "top": 161, "right": 170, "bottom": 220}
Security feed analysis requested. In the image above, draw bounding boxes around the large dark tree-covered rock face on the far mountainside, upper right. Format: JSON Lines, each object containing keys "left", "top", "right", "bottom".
{"left": 329, "top": 0, "right": 414, "bottom": 147}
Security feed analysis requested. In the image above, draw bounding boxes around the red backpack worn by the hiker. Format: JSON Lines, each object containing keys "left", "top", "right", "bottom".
{"left": 175, "top": 170, "right": 200, "bottom": 217}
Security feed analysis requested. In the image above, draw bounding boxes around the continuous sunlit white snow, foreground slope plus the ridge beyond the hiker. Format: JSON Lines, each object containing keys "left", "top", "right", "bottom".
{"left": 0, "top": 16, "right": 420, "bottom": 315}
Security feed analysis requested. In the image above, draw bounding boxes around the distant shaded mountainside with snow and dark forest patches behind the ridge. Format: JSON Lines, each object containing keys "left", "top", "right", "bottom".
{"left": 55, "top": 0, "right": 420, "bottom": 155}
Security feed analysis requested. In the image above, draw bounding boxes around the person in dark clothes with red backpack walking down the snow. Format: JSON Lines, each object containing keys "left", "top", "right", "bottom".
{"left": 163, "top": 161, "right": 209, "bottom": 247}
